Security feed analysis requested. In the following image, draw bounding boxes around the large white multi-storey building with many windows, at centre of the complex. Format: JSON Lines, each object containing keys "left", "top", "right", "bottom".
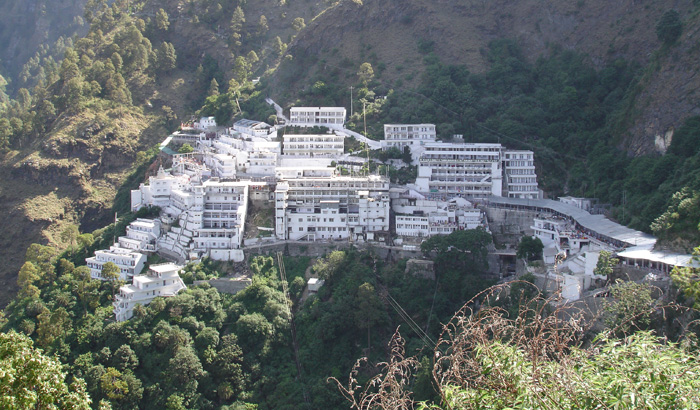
{"left": 275, "top": 176, "right": 390, "bottom": 241}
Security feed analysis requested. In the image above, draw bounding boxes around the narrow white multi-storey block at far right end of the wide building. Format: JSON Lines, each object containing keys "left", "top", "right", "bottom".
{"left": 503, "top": 150, "right": 539, "bottom": 199}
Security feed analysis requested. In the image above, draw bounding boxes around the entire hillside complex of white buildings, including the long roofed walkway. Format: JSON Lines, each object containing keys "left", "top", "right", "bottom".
{"left": 78, "top": 107, "right": 700, "bottom": 320}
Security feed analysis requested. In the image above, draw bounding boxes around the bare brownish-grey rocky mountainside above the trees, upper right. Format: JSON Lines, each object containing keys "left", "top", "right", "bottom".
{"left": 278, "top": 0, "right": 700, "bottom": 155}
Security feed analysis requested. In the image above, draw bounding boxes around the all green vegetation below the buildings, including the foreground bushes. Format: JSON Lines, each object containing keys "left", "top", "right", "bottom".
{"left": 0, "top": 215, "right": 700, "bottom": 409}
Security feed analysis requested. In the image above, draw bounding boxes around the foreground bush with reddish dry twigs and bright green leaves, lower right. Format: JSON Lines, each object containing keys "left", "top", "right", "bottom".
{"left": 335, "top": 284, "right": 700, "bottom": 410}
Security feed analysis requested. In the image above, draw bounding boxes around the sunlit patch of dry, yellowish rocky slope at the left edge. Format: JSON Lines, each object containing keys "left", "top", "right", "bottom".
{"left": 0, "top": 109, "right": 159, "bottom": 306}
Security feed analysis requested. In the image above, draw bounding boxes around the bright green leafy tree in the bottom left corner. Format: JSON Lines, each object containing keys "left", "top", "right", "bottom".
{"left": 0, "top": 330, "right": 91, "bottom": 410}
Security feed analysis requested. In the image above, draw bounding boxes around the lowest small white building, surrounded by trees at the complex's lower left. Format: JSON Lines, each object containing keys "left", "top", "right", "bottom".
{"left": 113, "top": 263, "right": 186, "bottom": 322}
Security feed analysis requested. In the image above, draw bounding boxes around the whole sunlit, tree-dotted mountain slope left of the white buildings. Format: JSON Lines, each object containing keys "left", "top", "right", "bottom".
{"left": 0, "top": 0, "right": 334, "bottom": 306}
